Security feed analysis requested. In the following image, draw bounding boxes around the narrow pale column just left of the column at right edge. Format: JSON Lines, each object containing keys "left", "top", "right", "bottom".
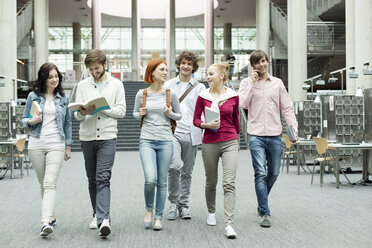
{"left": 344, "top": 0, "right": 356, "bottom": 95}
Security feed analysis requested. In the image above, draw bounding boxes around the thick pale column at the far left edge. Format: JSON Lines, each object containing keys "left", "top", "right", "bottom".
{"left": 0, "top": 0, "right": 17, "bottom": 102}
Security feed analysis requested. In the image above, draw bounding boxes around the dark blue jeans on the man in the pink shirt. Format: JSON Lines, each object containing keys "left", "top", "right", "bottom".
{"left": 248, "top": 135, "right": 282, "bottom": 216}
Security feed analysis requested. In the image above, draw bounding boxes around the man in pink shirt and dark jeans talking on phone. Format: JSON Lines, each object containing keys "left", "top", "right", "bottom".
{"left": 239, "top": 50, "right": 298, "bottom": 227}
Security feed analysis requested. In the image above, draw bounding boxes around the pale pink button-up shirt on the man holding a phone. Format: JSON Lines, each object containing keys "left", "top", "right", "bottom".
{"left": 239, "top": 75, "right": 298, "bottom": 136}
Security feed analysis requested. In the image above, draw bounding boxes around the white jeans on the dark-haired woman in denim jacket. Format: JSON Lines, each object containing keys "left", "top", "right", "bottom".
{"left": 28, "top": 149, "right": 65, "bottom": 222}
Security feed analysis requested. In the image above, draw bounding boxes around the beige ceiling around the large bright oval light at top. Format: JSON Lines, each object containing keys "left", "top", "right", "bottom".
{"left": 49, "top": 0, "right": 256, "bottom": 27}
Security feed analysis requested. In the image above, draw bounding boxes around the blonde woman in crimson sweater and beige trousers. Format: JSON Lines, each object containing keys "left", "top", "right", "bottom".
{"left": 194, "top": 64, "right": 240, "bottom": 238}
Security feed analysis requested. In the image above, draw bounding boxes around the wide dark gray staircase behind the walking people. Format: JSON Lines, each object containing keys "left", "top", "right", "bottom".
{"left": 71, "top": 82, "right": 247, "bottom": 151}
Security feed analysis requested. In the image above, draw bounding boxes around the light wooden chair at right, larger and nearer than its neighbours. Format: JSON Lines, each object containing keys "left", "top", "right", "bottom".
{"left": 311, "top": 137, "right": 351, "bottom": 187}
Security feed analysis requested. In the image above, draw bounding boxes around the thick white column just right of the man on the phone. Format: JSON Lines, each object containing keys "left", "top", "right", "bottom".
{"left": 288, "top": 0, "right": 307, "bottom": 101}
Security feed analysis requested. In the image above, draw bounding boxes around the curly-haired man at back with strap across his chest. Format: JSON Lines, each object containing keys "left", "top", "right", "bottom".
{"left": 165, "top": 51, "right": 205, "bottom": 220}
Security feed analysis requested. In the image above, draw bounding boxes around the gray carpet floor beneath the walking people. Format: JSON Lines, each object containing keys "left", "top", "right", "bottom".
{"left": 0, "top": 151, "right": 372, "bottom": 248}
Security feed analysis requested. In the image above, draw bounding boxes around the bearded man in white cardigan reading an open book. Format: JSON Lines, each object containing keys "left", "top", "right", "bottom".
{"left": 75, "top": 49, "right": 126, "bottom": 237}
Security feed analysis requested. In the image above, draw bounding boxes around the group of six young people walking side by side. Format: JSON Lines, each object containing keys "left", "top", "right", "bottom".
{"left": 22, "top": 49, "right": 297, "bottom": 238}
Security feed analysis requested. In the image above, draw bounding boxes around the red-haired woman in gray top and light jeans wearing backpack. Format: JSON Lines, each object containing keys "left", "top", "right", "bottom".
{"left": 133, "top": 60, "right": 182, "bottom": 231}
